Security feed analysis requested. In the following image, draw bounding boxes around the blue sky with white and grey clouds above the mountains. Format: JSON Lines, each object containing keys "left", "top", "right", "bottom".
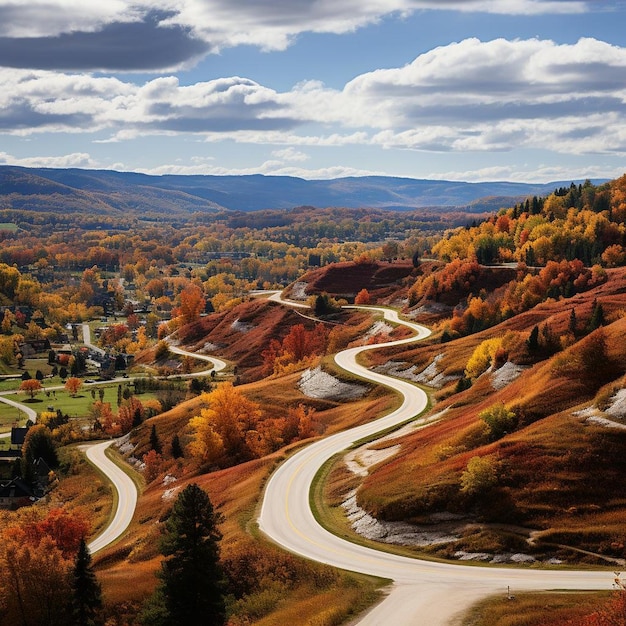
{"left": 0, "top": 0, "right": 626, "bottom": 182}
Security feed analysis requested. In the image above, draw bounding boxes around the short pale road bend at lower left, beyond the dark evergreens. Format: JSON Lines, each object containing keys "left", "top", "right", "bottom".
{"left": 80, "top": 440, "right": 137, "bottom": 553}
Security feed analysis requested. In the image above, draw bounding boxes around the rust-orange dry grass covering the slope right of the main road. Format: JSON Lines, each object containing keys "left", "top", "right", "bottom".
{"left": 358, "top": 271, "right": 626, "bottom": 564}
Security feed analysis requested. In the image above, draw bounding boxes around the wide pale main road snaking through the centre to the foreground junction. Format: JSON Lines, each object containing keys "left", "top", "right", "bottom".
{"left": 258, "top": 307, "right": 613, "bottom": 626}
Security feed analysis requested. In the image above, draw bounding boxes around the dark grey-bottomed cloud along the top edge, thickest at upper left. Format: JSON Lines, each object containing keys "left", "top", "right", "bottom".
{"left": 0, "top": 0, "right": 593, "bottom": 71}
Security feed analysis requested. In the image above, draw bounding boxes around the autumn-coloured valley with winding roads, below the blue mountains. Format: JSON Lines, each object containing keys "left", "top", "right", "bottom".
{"left": 0, "top": 172, "right": 626, "bottom": 626}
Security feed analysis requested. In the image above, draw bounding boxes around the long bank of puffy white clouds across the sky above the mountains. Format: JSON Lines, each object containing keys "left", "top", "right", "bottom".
{"left": 0, "top": 39, "right": 626, "bottom": 158}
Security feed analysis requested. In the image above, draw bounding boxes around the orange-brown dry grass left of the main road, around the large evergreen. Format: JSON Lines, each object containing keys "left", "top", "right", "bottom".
{"left": 95, "top": 374, "right": 393, "bottom": 626}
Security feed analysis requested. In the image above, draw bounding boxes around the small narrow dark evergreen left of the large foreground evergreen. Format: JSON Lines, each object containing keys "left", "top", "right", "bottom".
{"left": 71, "top": 539, "right": 103, "bottom": 626}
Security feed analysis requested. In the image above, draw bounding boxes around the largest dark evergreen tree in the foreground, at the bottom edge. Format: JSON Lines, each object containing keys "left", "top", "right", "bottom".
{"left": 144, "top": 483, "right": 226, "bottom": 626}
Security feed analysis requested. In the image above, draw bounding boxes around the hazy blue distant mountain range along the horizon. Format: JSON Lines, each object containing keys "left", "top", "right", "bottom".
{"left": 0, "top": 165, "right": 604, "bottom": 216}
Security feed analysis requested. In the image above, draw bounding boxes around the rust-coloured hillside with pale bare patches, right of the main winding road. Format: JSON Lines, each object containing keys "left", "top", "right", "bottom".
{"left": 357, "top": 268, "right": 626, "bottom": 563}
